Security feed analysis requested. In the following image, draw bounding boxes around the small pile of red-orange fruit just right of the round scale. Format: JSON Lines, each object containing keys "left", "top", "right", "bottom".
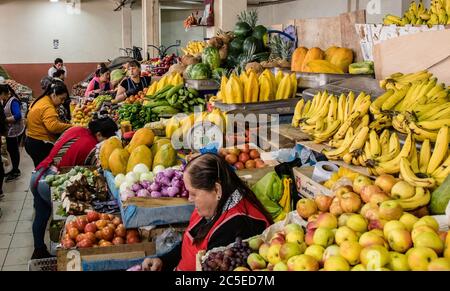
{"left": 219, "top": 144, "right": 266, "bottom": 170}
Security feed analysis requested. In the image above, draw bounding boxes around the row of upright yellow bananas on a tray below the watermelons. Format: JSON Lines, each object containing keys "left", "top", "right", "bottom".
{"left": 217, "top": 69, "right": 297, "bottom": 104}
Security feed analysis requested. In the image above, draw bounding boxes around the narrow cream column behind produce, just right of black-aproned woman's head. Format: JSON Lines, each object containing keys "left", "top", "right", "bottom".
{"left": 142, "top": 0, "right": 161, "bottom": 59}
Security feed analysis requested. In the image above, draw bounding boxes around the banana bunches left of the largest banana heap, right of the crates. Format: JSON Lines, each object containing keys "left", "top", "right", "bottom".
{"left": 292, "top": 91, "right": 371, "bottom": 145}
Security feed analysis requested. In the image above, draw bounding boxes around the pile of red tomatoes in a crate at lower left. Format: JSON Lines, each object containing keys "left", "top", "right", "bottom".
{"left": 61, "top": 211, "right": 140, "bottom": 249}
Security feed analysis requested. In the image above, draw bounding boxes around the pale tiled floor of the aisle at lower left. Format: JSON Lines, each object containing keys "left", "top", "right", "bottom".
{"left": 0, "top": 150, "right": 49, "bottom": 271}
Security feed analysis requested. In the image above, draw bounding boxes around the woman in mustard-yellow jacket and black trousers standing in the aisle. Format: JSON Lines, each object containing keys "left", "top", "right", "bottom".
{"left": 25, "top": 81, "right": 72, "bottom": 167}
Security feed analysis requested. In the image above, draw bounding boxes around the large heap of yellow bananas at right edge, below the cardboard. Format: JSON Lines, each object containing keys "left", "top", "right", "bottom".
{"left": 370, "top": 71, "right": 450, "bottom": 142}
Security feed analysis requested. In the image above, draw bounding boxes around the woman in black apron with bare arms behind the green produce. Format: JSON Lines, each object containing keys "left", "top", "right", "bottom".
{"left": 113, "top": 61, "right": 151, "bottom": 103}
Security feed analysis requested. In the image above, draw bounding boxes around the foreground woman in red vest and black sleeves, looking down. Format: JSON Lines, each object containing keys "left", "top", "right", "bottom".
{"left": 142, "top": 154, "right": 273, "bottom": 271}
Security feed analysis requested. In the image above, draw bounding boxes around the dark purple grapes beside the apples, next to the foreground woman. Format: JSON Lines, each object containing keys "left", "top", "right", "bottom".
{"left": 202, "top": 238, "right": 252, "bottom": 272}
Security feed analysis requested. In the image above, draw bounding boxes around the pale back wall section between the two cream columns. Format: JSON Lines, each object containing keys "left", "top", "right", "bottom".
{"left": 161, "top": 9, "right": 205, "bottom": 53}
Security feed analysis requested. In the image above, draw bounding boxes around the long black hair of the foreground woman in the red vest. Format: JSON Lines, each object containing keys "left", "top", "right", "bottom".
{"left": 185, "top": 153, "right": 273, "bottom": 244}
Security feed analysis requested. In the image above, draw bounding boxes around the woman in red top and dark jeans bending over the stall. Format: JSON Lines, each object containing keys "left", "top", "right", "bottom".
{"left": 30, "top": 118, "right": 118, "bottom": 259}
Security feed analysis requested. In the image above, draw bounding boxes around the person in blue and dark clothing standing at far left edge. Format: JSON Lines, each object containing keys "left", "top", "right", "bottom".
{"left": 0, "top": 84, "right": 25, "bottom": 182}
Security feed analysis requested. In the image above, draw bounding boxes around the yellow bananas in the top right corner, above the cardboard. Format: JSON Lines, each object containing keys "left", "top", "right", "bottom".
{"left": 383, "top": 0, "right": 450, "bottom": 26}
